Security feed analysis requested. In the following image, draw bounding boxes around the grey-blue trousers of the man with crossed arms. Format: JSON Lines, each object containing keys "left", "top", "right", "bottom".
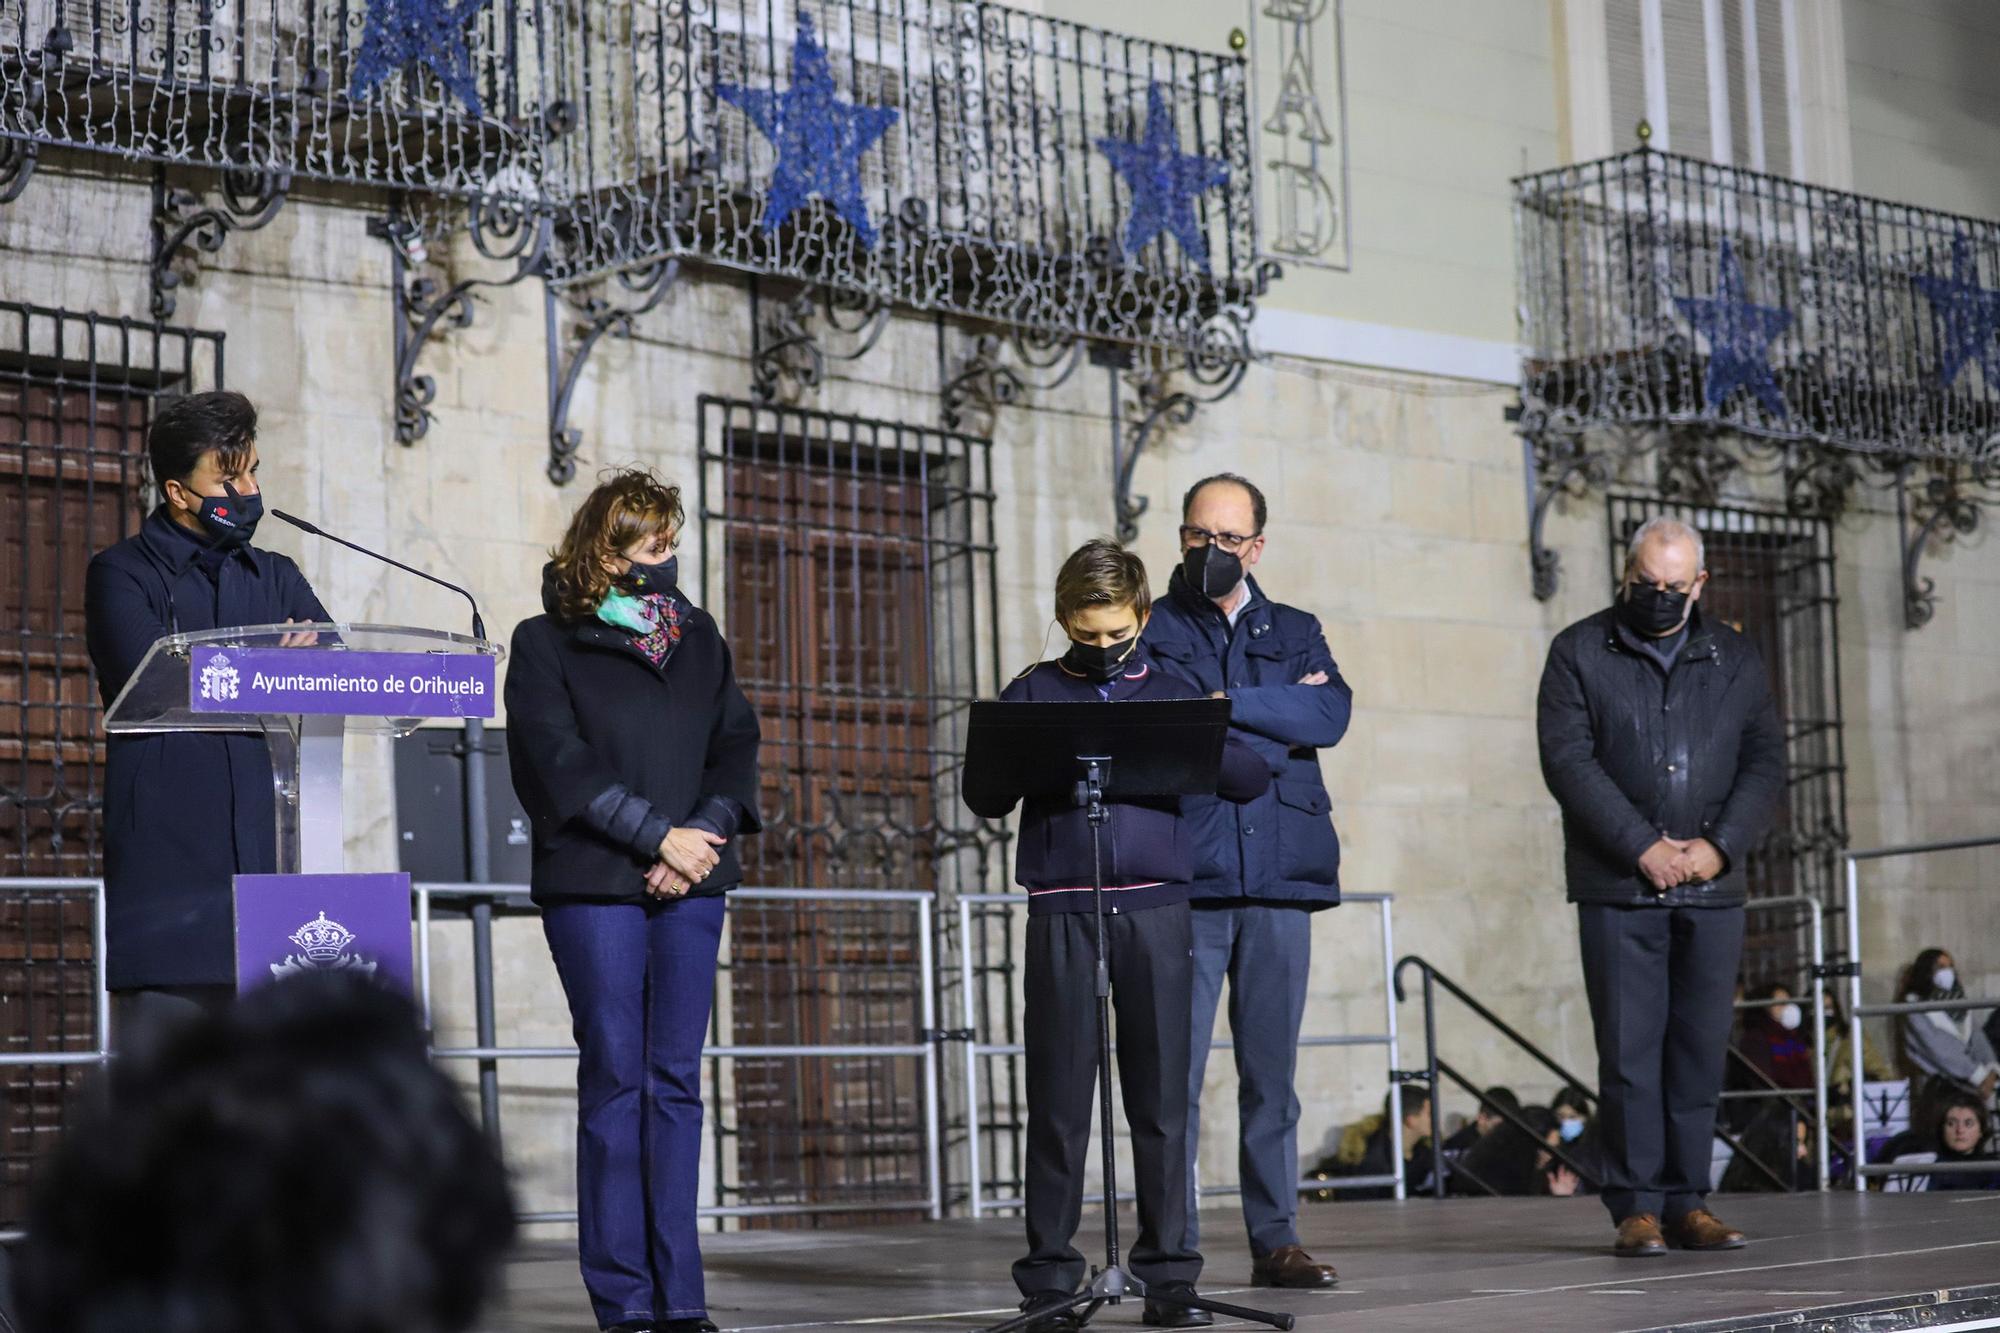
{"left": 1188, "top": 903, "right": 1312, "bottom": 1255}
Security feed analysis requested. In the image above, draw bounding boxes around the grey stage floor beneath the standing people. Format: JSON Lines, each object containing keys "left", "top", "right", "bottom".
{"left": 486, "top": 1191, "right": 2000, "bottom": 1333}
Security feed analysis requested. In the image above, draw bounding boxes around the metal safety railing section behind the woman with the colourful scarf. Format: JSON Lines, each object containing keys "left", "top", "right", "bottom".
{"left": 412, "top": 883, "right": 944, "bottom": 1223}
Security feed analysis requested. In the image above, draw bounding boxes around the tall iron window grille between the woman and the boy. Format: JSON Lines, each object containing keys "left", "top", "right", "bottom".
{"left": 700, "top": 398, "right": 1012, "bottom": 1223}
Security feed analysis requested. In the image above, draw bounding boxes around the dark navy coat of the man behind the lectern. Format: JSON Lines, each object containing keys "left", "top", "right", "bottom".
{"left": 84, "top": 506, "right": 328, "bottom": 991}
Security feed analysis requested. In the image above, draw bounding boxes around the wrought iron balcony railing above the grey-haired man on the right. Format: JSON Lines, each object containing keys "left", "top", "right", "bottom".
{"left": 1514, "top": 150, "right": 2000, "bottom": 624}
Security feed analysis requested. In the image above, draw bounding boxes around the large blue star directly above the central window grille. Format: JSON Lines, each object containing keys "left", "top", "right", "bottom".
{"left": 716, "top": 14, "right": 900, "bottom": 250}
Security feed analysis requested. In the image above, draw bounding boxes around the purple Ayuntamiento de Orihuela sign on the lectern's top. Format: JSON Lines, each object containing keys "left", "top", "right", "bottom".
{"left": 188, "top": 648, "right": 494, "bottom": 717}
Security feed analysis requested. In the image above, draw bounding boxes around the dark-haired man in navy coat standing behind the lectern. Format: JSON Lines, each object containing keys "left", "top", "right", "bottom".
{"left": 84, "top": 392, "right": 328, "bottom": 1027}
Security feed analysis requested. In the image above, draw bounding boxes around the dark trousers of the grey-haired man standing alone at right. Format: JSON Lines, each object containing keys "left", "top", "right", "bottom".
{"left": 1576, "top": 903, "right": 1744, "bottom": 1223}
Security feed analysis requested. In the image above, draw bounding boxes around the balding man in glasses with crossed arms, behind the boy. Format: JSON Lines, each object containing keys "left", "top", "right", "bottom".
{"left": 1146, "top": 472, "right": 1352, "bottom": 1287}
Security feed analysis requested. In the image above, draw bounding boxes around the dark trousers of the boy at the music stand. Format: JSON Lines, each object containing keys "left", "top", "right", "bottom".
{"left": 1014, "top": 903, "right": 1202, "bottom": 1295}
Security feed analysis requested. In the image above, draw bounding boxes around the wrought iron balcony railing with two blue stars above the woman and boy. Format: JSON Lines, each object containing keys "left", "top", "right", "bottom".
{"left": 554, "top": 0, "right": 1266, "bottom": 342}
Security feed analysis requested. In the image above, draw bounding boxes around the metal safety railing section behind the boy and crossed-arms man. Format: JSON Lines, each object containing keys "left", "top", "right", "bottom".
{"left": 958, "top": 893, "right": 1404, "bottom": 1217}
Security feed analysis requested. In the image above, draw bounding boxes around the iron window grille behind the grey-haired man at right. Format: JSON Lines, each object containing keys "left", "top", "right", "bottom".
{"left": 1610, "top": 494, "right": 1848, "bottom": 980}
